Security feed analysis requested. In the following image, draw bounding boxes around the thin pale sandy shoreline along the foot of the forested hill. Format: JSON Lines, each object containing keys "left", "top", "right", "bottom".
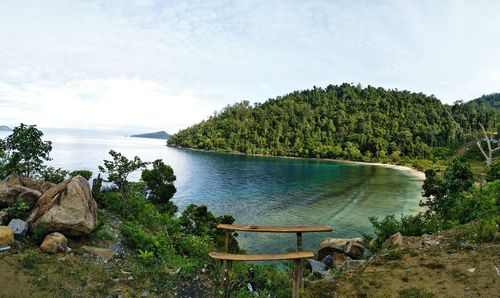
{"left": 167, "top": 145, "right": 425, "bottom": 181}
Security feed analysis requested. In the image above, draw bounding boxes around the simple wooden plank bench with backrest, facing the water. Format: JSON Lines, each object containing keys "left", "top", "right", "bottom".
{"left": 209, "top": 224, "right": 333, "bottom": 298}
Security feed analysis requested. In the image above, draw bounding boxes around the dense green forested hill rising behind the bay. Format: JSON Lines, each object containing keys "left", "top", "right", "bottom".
{"left": 168, "top": 84, "right": 498, "bottom": 160}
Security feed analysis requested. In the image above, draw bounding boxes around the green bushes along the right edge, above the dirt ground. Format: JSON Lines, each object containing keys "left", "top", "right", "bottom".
{"left": 370, "top": 159, "right": 500, "bottom": 244}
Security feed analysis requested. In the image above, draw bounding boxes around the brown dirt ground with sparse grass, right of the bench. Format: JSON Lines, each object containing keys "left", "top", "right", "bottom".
{"left": 334, "top": 234, "right": 500, "bottom": 297}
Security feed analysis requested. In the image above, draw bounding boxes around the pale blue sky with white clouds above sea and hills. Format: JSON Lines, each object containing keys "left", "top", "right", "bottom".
{"left": 0, "top": 0, "right": 500, "bottom": 133}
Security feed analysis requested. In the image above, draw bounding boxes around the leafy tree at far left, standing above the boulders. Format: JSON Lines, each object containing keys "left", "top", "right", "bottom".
{"left": 5, "top": 123, "right": 52, "bottom": 177}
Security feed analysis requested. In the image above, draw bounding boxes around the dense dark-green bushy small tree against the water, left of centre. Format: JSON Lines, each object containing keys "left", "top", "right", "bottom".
{"left": 141, "top": 159, "right": 177, "bottom": 214}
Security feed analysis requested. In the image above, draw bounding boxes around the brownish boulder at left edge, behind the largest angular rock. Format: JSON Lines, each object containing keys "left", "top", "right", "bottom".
{"left": 0, "top": 175, "right": 55, "bottom": 207}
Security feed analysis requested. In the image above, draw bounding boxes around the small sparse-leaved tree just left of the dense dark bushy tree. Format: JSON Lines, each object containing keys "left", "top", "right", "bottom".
{"left": 99, "top": 150, "right": 148, "bottom": 192}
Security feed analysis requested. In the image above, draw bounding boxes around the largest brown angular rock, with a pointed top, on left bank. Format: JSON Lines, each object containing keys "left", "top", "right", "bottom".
{"left": 28, "top": 176, "right": 97, "bottom": 236}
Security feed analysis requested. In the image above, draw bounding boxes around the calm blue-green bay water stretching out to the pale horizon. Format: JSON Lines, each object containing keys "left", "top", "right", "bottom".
{"left": 0, "top": 130, "right": 421, "bottom": 252}
